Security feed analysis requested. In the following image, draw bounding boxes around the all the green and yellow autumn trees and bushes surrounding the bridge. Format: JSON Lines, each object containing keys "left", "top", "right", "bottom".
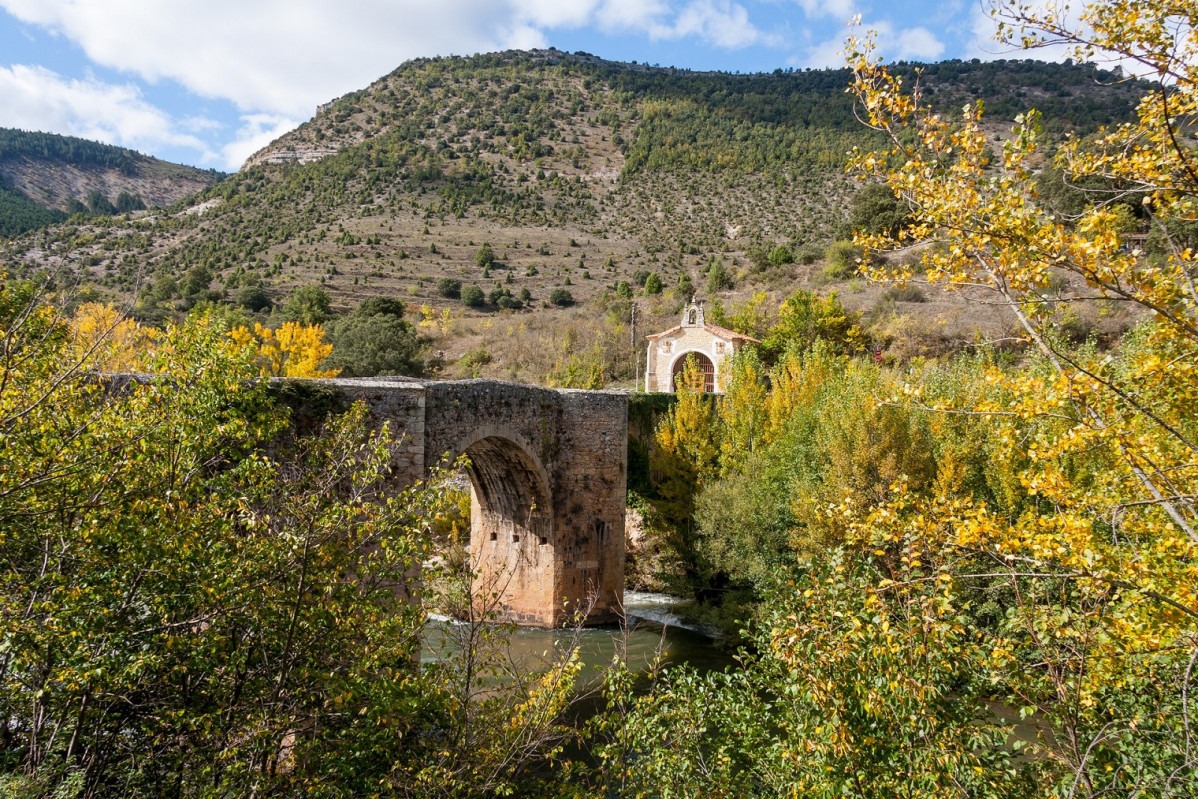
{"left": 0, "top": 0, "right": 1198, "bottom": 799}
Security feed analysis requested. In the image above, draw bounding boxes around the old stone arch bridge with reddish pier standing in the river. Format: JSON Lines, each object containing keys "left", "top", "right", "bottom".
{"left": 286, "top": 377, "right": 628, "bottom": 627}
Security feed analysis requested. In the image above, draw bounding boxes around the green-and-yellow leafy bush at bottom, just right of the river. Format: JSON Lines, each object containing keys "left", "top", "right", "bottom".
{"left": 575, "top": 551, "right": 1036, "bottom": 799}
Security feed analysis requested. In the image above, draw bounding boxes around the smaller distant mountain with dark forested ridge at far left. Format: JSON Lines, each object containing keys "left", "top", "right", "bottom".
{"left": 0, "top": 128, "right": 223, "bottom": 236}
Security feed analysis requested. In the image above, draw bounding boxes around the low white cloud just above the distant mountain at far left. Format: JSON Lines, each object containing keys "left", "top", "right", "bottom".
{"left": 0, "top": 63, "right": 217, "bottom": 161}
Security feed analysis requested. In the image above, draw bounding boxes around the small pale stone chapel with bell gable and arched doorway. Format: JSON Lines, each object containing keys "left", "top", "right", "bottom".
{"left": 645, "top": 299, "right": 761, "bottom": 392}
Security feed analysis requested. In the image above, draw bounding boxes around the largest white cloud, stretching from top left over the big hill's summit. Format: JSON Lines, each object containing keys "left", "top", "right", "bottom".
{"left": 0, "top": 0, "right": 760, "bottom": 125}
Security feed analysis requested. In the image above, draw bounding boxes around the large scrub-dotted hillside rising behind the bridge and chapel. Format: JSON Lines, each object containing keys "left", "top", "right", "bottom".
{"left": 0, "top": 50, "right": 1139, "bottom": 383}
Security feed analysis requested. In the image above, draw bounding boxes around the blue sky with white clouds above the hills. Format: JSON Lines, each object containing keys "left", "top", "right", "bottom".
{"left": 0, "top": 0, "right": 1022, "bottom": 171}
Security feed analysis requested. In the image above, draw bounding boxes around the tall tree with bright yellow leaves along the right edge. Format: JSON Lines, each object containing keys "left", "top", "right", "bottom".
{"left": 838, "top": 0, "right": 1198, "bottom": 795}
